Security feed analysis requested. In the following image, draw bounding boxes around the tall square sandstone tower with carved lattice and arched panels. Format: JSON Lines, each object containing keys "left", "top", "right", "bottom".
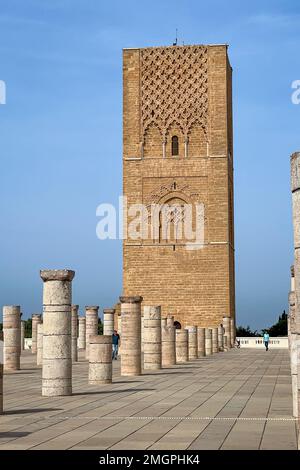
{"left": 123, "top": 45, "right": 235, "bottom": 327}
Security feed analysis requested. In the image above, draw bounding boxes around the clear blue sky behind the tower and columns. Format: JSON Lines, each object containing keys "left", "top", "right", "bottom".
{"left": 0, "top": 0, "right": 300, "bottom": 328}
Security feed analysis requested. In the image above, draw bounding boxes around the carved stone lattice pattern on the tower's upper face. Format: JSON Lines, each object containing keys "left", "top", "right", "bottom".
{"left": 141, "top": 46, "right": 208, "bottom": 138}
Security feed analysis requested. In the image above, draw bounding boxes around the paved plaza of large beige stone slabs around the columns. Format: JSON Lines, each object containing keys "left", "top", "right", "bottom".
{"left": 0, "top": 349, "right": 296, "bottom": 450}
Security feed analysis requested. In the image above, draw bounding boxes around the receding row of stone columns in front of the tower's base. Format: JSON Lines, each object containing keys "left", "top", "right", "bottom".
{"left": 119, "top": 296, "right": 234, "bottom": 376}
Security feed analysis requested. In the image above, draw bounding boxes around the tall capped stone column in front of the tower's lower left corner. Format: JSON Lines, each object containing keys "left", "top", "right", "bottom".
{"left": 120, "top": 296, "right": 143, "bottom": 376}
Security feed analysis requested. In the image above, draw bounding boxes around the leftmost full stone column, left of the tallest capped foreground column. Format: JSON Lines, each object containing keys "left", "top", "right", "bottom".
{"left": 3, "top": 305, "right": 21, "bottom": 371}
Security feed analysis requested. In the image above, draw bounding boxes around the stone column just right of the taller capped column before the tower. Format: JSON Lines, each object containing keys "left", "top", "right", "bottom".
{"left": 143, "top": 305, "right": 162, "bottom": 370}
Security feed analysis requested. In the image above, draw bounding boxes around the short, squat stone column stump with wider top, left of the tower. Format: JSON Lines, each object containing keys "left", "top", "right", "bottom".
{"left": 89, "top": 335, "right": 112, "bottom": 385}
